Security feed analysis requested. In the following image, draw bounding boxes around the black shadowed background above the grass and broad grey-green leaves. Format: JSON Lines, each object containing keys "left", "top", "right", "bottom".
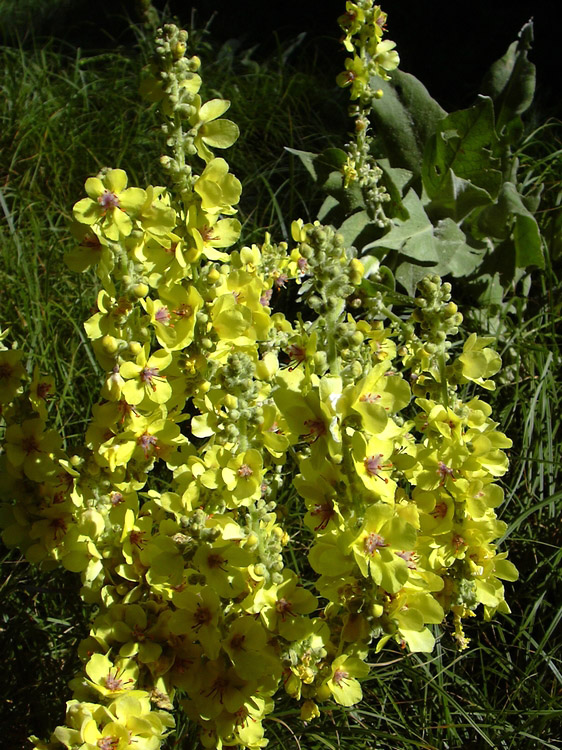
{"left": 0, "top": 0, "right": 562, "bottom": 119}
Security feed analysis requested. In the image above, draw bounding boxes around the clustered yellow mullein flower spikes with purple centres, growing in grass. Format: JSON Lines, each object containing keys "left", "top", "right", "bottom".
{"left": 0, "top": 7, "right": 517, "bottom": 750}
